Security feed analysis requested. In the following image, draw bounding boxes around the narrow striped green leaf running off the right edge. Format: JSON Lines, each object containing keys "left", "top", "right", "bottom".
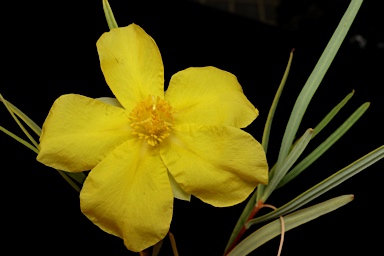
{"left": 245, "top": 146, "right": 384, "bottom": 228}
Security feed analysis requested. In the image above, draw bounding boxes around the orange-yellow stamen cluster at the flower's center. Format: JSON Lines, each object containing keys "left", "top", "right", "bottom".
{"left": 129, "top": 95, "right": 173, "bottom": 146}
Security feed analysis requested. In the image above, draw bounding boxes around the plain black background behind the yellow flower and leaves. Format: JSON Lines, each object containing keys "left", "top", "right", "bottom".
{"left": 0, "top": 0, "right": 384, "bottom": 255}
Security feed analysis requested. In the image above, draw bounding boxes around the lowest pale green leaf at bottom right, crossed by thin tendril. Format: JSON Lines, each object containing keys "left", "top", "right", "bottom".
{"left": 228, "top": 195, "right": 353, "bottom": 256}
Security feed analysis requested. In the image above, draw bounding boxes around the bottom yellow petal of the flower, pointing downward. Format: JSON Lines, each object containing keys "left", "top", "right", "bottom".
{"left": 80, "top": 139, "right": 173, "bottom": 252}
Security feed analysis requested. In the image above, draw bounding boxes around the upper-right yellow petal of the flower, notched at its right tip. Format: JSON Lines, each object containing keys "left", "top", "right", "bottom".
{"left": 165, "top": 67, "right": 258, "bottom": 128}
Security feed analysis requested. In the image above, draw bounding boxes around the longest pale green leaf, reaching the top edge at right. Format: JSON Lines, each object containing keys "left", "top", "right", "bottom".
{"left": 276, "top": 0, "right": 363, "bottom": 174}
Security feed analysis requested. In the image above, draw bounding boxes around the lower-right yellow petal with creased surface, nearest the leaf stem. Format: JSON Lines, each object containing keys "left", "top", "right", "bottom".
{"left": 160, "top": 124, "right": 268, "bottom": 207}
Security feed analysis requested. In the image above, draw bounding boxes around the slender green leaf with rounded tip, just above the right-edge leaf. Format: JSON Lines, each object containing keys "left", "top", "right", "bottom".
{"left": 277, "top": 102, "right": 370, "bottom": 188}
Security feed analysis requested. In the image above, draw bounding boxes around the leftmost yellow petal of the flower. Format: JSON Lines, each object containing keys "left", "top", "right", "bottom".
{"left": 37, "top": 94, "right": 132, "bottom": 172}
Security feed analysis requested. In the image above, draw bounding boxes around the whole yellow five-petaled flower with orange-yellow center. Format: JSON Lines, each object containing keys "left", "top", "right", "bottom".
{"left": 37, "top": 24, "right": 268, "bottom": 251}
